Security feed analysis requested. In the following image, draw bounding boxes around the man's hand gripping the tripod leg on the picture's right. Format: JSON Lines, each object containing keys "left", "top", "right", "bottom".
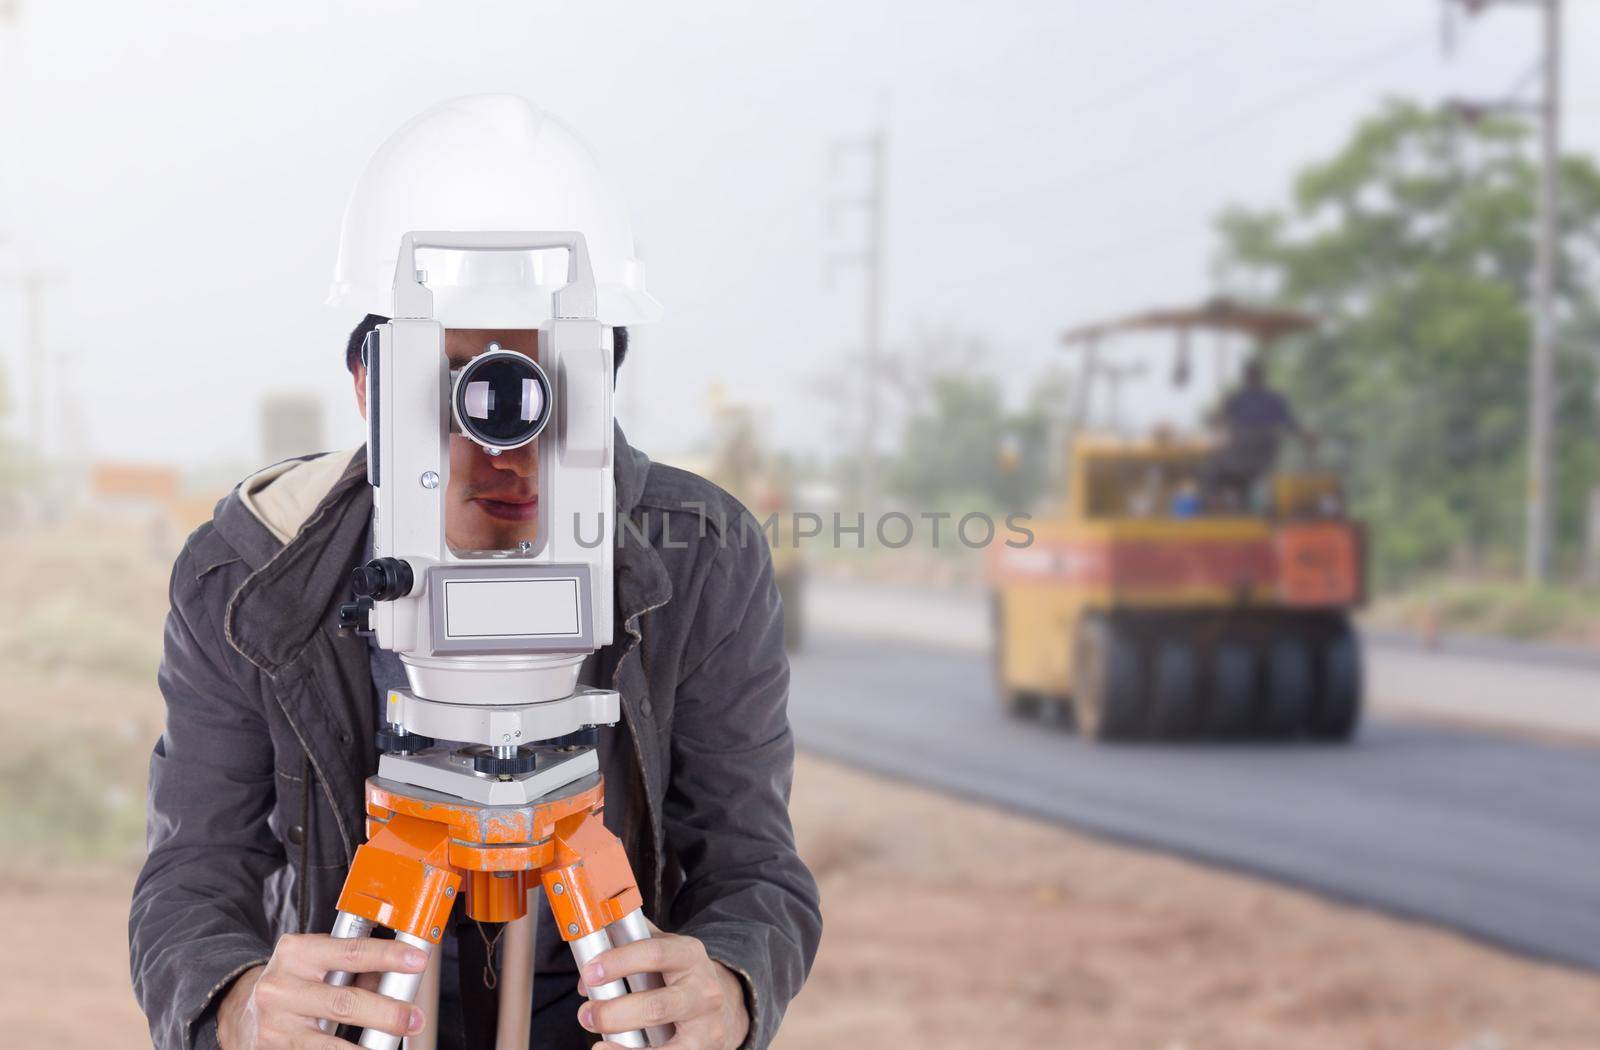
{"left": 578, "top": 932, "right": 750, "bottom": 1050}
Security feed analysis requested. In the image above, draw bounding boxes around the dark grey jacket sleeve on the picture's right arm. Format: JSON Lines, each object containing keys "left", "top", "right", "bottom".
{"left": 664, "top": 525, "right": 822, "bottom": 1050}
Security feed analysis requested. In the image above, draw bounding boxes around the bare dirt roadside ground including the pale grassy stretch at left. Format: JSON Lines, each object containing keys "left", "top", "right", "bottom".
{"left": 9, "top": 531, "right": 1600, "bottom": 1050}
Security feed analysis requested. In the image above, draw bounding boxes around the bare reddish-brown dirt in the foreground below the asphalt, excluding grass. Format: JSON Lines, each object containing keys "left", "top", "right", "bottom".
{"left": 0, "top": 757, "right": 1600, "bottom": 1050}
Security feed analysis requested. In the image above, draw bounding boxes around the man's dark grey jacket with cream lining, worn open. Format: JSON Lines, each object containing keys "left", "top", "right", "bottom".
{"left": 128, "top": 429, "right": 822, "bottom": 1050}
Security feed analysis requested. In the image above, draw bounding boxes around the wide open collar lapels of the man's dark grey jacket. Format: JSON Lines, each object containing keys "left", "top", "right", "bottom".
{"left": 213, "top": 426, "right": 672, "bottom": 674}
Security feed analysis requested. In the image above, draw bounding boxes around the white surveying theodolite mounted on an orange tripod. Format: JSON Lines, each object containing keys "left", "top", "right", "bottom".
{"left": 328, "top": 232, "right": 672, "bottom": 1050}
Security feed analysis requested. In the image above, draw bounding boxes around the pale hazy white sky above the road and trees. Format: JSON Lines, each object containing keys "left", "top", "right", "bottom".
{"left": 0, "top": 0, "right": 1600, "bottom": 464}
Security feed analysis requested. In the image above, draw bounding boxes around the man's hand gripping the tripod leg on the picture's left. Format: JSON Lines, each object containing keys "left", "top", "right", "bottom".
{"left": 216, "top": 933, "right": 427, "bottom": 1050}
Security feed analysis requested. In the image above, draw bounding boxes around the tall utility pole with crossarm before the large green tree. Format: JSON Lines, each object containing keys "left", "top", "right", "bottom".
{"left": 1445, "top": 0, "right": 1562, "bottom": 584}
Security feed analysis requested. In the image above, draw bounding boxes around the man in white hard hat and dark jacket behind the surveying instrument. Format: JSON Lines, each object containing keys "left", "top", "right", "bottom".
{"left": 130, "top": 96, "right": 821, "bottom": 1050}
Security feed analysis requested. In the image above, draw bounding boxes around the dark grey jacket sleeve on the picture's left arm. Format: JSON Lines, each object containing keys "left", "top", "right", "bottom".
{"left": 128, "top": 533, "right": 285, "bottom": 1050}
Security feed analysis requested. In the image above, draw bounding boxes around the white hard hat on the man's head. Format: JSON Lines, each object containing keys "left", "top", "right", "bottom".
{"left": 328, "top": 94, "right": 661, "bottom": 328}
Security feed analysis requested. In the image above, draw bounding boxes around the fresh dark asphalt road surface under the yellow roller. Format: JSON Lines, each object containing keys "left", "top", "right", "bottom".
{"left": 790, "top": 634, "right": 1600, "bottom": 970}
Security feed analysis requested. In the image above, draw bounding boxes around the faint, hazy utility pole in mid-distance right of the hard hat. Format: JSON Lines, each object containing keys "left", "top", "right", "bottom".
{"left": 829, "top": 126, "right": 888, "bottom": 512}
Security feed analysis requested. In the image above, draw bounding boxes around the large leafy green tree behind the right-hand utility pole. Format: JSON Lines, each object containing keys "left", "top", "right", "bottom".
{"left": 1218, "top": 101, "right": 1600, "bottom": 584}
